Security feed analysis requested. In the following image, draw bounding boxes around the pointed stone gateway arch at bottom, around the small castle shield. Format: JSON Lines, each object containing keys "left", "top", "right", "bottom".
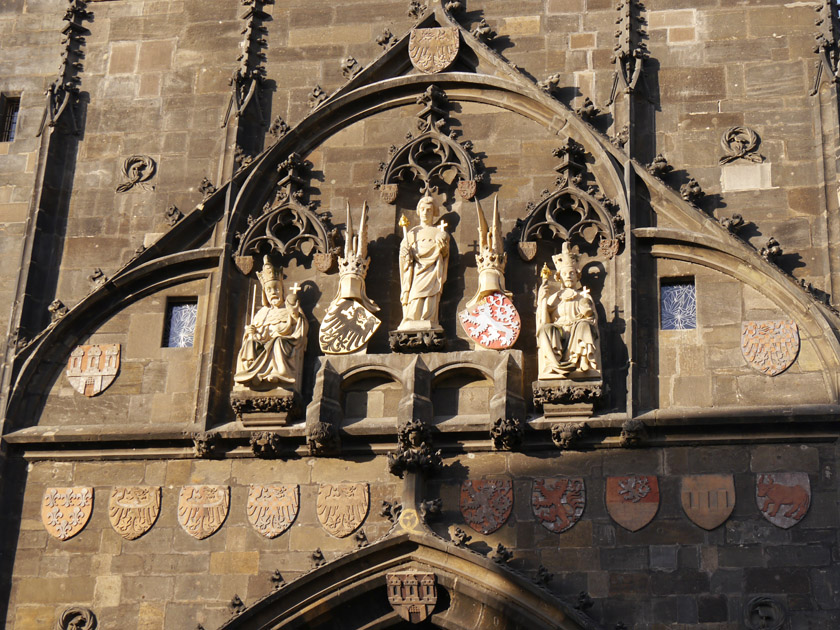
{"left": 215, "top": 534, "right": 602, "bottom": 630}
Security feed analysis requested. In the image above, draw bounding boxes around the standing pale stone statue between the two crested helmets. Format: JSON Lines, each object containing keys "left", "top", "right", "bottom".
{"left": 398, "top": 194, "right": 449, "bottom": 331}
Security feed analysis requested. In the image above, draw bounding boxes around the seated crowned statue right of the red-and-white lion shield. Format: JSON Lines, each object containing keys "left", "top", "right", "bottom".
{"left": 537, "top": 241, "right": 601, "bottom": 381}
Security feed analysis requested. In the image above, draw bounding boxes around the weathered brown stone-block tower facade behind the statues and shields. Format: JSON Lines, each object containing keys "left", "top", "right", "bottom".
{"left": 0, "top": 0, "right": 840, "bottom": 630}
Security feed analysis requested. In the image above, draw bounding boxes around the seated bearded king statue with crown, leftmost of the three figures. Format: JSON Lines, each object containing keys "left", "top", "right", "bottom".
{"left": 233, "top": 256, "right": 307, "bottom": 391}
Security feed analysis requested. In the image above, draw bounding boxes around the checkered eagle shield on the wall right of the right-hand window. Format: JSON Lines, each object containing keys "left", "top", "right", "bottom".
{"left": 741, "top": 319, "right": 799, "bottom": 376}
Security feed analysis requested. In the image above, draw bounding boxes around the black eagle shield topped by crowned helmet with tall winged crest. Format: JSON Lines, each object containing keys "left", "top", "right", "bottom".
{"left": 318, "top": 204, "right": 381, "bottom": 354}
